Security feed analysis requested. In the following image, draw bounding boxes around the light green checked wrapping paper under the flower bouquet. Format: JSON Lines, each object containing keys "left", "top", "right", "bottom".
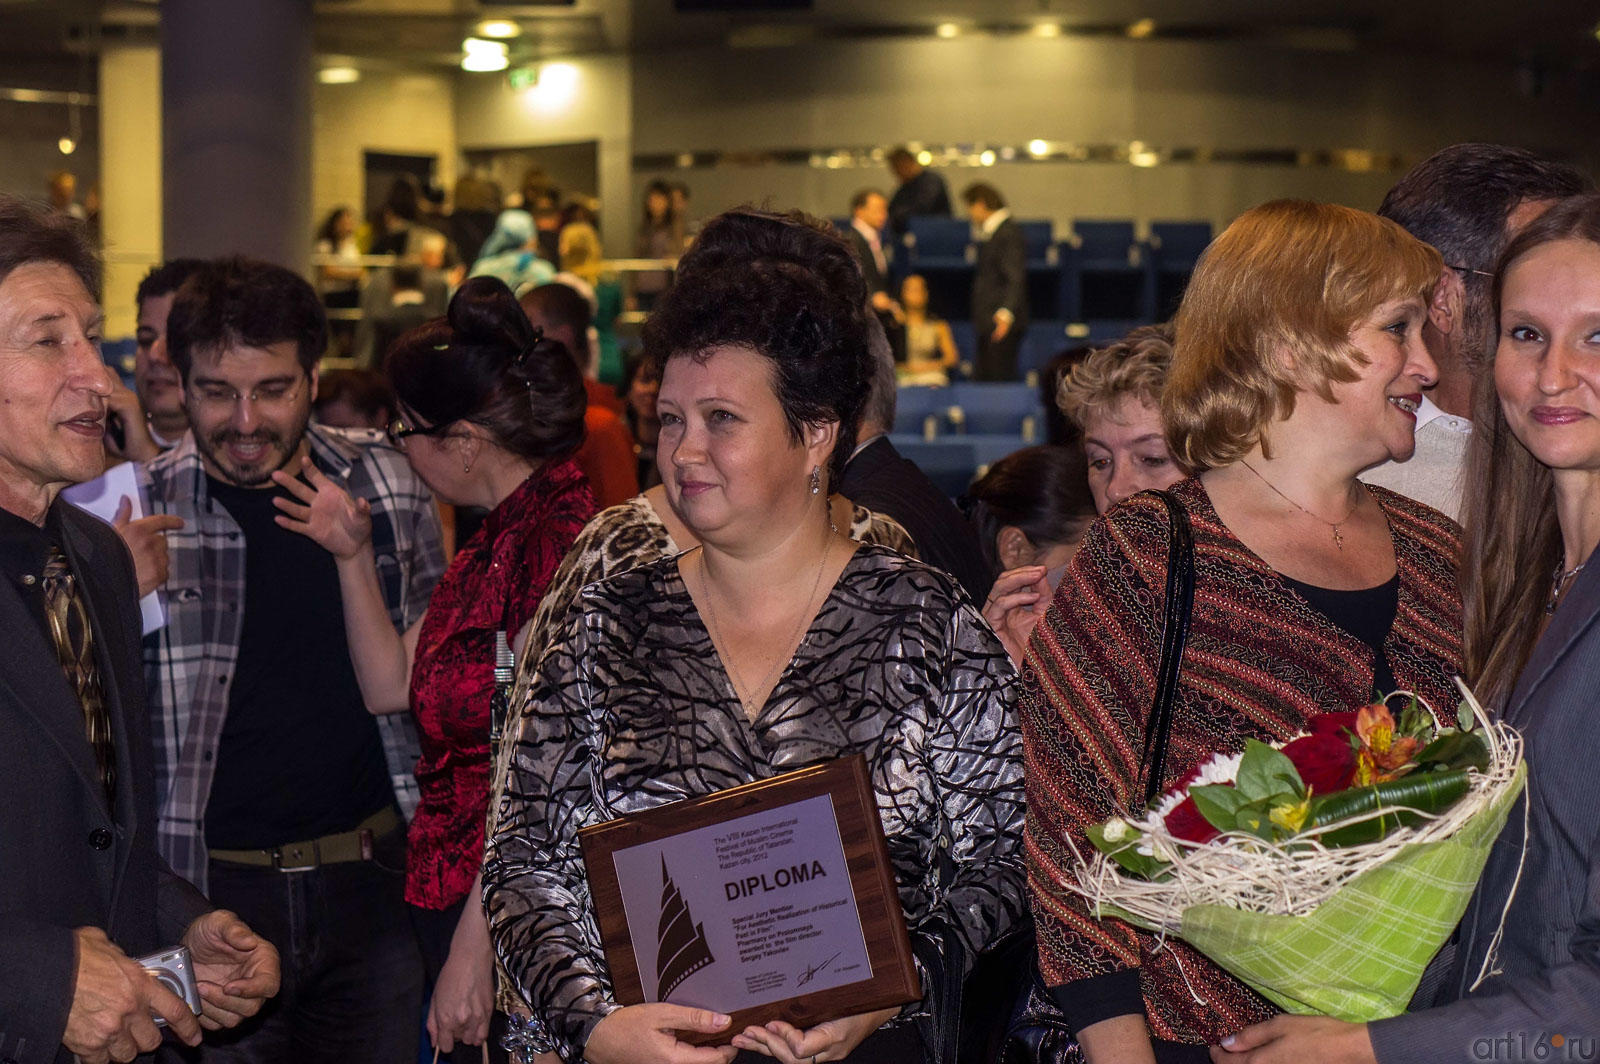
{"left": 1099, "top": 765, "right": 1528, "bottom": 1022}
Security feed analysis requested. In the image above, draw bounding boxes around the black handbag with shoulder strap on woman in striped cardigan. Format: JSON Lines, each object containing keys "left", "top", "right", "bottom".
{"left": 998, "top": 491, "right": 1195, "bottom": 1064}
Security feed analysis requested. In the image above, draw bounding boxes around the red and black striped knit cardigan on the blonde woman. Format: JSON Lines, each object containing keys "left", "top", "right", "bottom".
{"left": 1019, "top": 480, "right": 1461, "bottom": 1045}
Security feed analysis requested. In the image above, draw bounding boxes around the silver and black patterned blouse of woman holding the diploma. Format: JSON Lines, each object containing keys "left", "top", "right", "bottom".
{"left": 483, "top": 546, "right": 1024, "bottom": 1061}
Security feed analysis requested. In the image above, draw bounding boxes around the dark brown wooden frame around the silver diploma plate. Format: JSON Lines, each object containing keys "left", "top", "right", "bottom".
{"left": 578, "top": 754, "right": 922, "bottom": 1045}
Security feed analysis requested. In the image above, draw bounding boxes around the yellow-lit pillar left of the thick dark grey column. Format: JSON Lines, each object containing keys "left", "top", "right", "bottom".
{"left": 99, "top": 45, "right": 162, "bottom": 339}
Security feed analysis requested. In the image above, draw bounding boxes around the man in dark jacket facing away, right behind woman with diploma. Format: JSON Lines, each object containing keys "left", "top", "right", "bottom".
{"left": 838, "top": 315, "right": 994, "bottom": 608}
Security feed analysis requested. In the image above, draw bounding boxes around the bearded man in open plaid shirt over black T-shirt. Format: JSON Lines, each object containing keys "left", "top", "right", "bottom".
{"left": 144, "top": 259, "right": 443, "bottom": 1062}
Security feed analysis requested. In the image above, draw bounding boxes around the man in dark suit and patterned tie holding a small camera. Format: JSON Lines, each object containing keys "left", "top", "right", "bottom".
{"left": 0, "top": 197, "right": 278, "bottom": 1064}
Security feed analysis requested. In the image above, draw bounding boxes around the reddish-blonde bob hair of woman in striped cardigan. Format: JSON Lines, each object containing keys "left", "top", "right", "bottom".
{"left": 1162, "top": 200, "right": 1445, "bottom": 472}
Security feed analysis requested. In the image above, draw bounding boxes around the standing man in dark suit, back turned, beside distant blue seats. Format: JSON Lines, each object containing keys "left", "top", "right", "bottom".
{"left": 962, "top": 182, "right": 1027, "bottom": 381}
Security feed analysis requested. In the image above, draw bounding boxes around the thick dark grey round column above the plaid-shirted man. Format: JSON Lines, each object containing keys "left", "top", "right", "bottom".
{"left": 162, "top": 0, "right": 314, "bottom": 270}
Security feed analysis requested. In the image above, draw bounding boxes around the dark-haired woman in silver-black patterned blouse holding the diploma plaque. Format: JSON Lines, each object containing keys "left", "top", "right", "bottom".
{"left": 485, "top": 211, "right": 1022, "bottom": 1064}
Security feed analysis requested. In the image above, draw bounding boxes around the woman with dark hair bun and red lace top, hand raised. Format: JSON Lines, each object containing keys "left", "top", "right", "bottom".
{"left": 274, "top": 277, "right": 595, "bottom": 1061}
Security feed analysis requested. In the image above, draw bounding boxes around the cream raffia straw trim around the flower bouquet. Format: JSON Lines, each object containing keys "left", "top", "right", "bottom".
{"left": 1066, "top": 686, "right": 1522, "bottom": 934}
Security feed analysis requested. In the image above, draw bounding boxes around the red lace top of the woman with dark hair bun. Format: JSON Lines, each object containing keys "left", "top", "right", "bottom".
{"left": 405, "top": 461, "right": 595, "bottom": 909}
